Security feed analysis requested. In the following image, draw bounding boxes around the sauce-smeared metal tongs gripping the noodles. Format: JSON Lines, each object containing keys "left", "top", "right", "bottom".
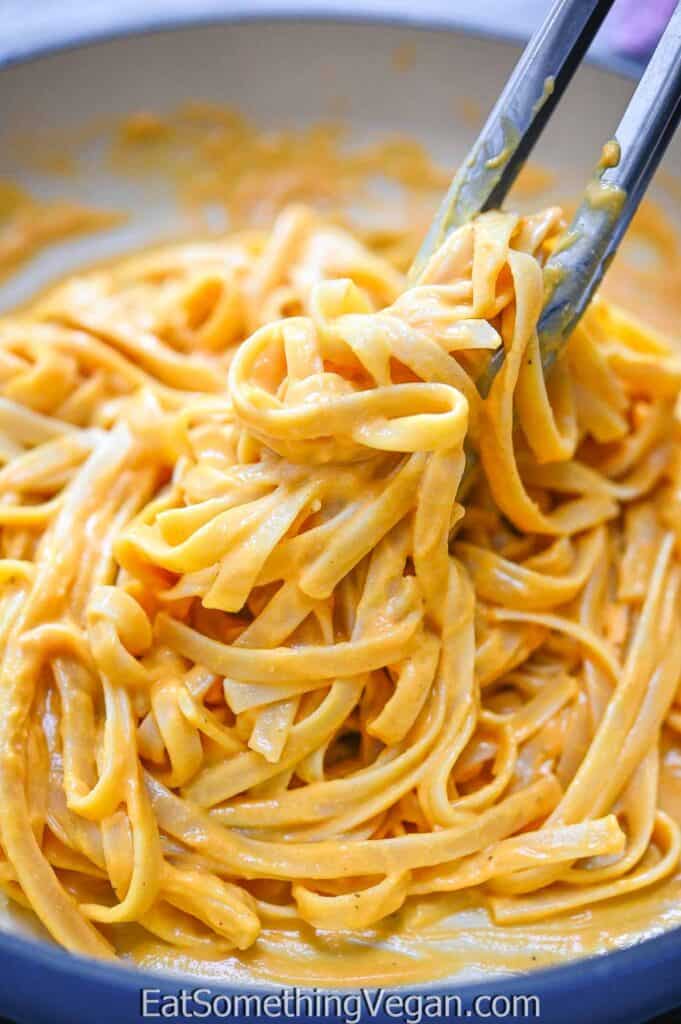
{"left": 411, "top": 0, "right": 681, "bottom": 397}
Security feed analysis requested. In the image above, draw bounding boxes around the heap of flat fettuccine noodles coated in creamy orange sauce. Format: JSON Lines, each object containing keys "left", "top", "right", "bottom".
{"left": 0, "top": 199, "right": 681, "bottom": 983}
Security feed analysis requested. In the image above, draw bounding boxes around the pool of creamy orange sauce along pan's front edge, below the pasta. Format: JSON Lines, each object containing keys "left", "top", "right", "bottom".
{"left": 104, "top": 750, "right": 681, "bottom": 987}
